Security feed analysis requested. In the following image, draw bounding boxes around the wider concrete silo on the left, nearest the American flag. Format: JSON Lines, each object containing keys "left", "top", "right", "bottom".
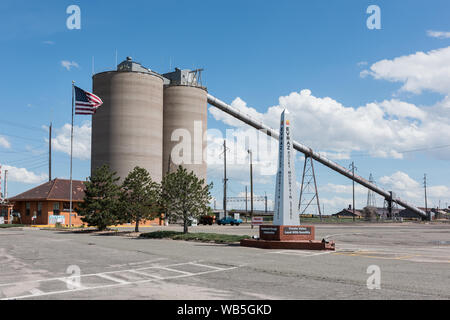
{"left": 91, "top": 58, "right": 163, "bottom": 182}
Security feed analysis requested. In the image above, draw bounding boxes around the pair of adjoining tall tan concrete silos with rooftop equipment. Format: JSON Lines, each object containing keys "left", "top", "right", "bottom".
{"left": 91, "top": 57, "right": 207, "bottom": 182}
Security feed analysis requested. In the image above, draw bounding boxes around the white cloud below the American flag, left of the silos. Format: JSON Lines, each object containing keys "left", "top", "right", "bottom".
{"left": 47, "top": 121, "right": 92, "bottom": 160}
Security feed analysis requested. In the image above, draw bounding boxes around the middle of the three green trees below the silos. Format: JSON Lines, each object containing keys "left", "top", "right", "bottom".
{"left": 119, "top": 167, "right": 160, "bottom": 232}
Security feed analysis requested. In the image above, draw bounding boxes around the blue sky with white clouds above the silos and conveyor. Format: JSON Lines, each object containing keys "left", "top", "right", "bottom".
{"left": 0, "top": 0, "right": 450, "bottom": 213}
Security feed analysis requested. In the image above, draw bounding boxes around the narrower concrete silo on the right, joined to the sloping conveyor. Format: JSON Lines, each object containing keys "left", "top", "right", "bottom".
{"left": 163, "top": 69, "right": 207, "bottom": 182}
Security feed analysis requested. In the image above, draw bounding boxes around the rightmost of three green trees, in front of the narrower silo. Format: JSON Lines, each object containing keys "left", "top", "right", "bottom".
{"left": 162, "top": 166, "right": 212, "bottom": 233}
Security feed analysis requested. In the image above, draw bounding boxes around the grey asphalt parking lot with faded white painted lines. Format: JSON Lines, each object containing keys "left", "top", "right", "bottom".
{"left": 0, "top": 223, "right": 450, "bottom": 300}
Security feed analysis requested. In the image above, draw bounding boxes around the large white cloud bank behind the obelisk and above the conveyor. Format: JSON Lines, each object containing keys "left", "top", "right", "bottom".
{"left": 210, "top": 90, "right": 450, "bottom": 160}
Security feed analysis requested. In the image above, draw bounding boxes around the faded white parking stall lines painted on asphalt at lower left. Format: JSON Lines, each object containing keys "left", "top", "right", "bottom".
{"left": 0, "top": 261, "right": 239, "bottom": 300}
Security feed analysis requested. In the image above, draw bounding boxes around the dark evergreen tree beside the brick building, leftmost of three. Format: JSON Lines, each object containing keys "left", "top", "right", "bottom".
{"left": 75, "top": 165, "right": 120, "bottom": 230}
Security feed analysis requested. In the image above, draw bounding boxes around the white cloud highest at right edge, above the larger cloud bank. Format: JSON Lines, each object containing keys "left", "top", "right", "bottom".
{"left": 361, "top": 47, "right": 450, "bottom": 94}
